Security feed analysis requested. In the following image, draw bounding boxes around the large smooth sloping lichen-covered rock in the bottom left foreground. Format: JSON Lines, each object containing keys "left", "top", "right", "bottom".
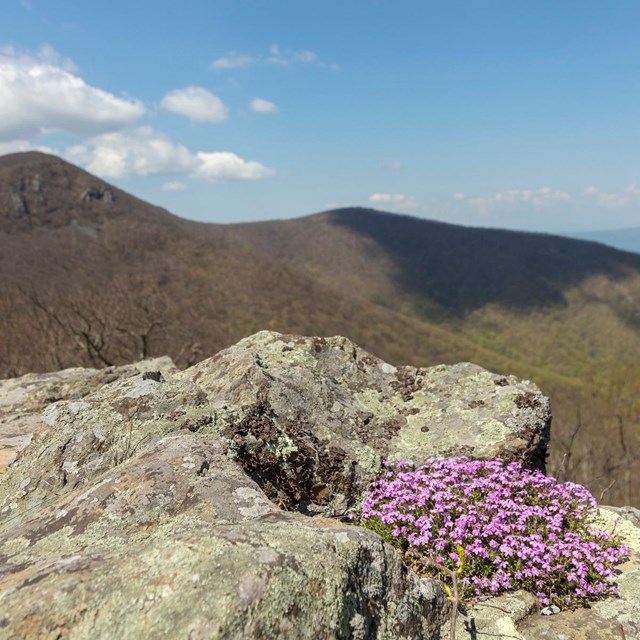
{"left": 0, "top": 434, "right": 446, "bottom": 640}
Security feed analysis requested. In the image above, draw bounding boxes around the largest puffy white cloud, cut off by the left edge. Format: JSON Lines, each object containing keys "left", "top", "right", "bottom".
{"left": 0, "top": 47, "right": 145, "bottom": 141}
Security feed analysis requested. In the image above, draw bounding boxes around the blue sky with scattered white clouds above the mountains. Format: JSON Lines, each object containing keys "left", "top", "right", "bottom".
{"left": 0, "top": 0, "right": 640, "bottom": 232}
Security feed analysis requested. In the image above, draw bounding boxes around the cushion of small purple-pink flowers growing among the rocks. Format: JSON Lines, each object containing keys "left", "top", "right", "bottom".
{"left": 362, "top": 457, "right": 628, "bottom": 608}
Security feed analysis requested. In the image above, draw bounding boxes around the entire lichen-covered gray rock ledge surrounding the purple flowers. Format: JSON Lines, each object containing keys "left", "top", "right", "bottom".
{"left": 0, "top": 332, "right": 640, "bottom": 640}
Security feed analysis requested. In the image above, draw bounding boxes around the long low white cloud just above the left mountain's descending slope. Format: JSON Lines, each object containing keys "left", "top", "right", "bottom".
{"left": 66, "top": 127, "right": 275, "bottom": 182}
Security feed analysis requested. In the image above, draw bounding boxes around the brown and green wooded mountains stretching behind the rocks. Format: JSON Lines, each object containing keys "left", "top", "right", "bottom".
{"left": 0, "top": 153, "right": 640, "bottom": 504}
